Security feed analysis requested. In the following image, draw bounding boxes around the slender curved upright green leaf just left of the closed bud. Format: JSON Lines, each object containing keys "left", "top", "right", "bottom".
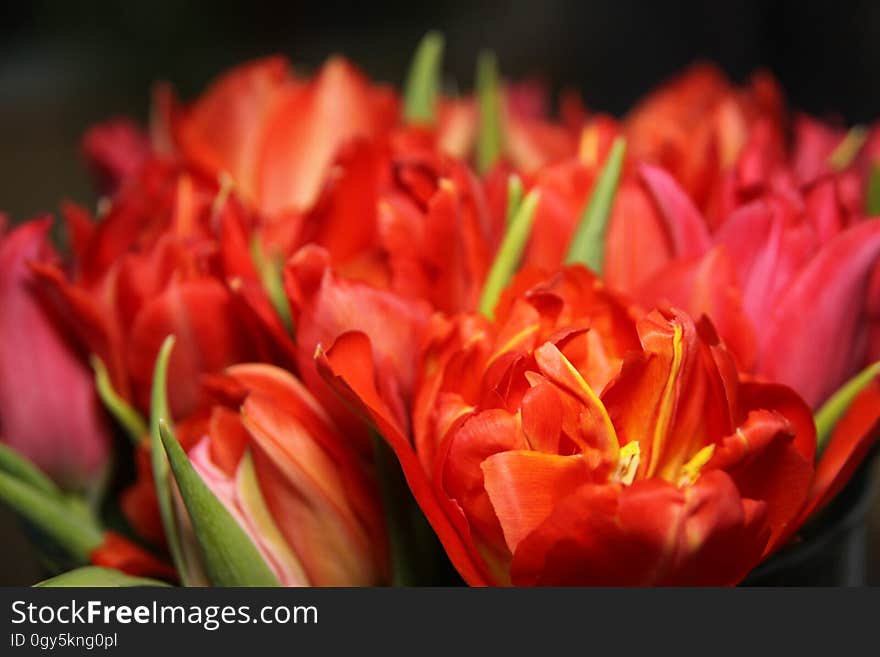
{"left": 150, "top": 335, "right": 189, "bottom": 584}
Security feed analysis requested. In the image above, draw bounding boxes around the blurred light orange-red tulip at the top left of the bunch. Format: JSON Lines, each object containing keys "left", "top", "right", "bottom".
{"left": 168, "top": 57, "right": 398, "bottom": 216}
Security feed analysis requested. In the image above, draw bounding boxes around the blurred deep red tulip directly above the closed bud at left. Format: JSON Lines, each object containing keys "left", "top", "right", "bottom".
{"left": 35, "top": 157, "right": 265, "bottom": 415}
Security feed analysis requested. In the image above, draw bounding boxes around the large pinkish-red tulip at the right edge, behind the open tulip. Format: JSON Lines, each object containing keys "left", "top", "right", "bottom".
{"left": 606, "top": 161, "right": 880, "bottom": 408}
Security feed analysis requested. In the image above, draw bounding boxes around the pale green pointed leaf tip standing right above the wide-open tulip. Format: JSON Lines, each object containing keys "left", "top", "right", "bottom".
{"left": 565, "top": 137, "right": 626, "bottom": 275}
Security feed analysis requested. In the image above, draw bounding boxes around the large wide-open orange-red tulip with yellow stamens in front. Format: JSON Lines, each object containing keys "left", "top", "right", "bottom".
{"left": 317, "top": 266, "right": 876, "bottom": 585}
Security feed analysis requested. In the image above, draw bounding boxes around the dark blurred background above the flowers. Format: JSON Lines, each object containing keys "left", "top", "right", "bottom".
{"left": 0, "top": 0, "right": 880, "bottom": 584}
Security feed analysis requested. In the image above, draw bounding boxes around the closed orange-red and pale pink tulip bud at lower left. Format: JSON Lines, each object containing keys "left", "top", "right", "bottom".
{"left": 180, "top": 364, "right": 388, "bottom": 586}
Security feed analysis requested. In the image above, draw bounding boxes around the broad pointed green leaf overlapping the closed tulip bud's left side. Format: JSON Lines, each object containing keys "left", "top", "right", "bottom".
{"left": 159, "top": 422, "right": 278, "bottom": 586}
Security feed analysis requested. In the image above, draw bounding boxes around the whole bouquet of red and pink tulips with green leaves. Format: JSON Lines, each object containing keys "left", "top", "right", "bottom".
{"left": 0, "top": 33, "right": 880, "bottom": 586}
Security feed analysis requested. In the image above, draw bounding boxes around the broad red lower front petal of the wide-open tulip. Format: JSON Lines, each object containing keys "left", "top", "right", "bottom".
{"left": 511, "top": 472, "right": 767, "bottom": 586}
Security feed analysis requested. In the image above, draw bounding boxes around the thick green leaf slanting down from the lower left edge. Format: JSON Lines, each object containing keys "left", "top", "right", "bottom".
{"left": 0, "top": 471, "right": 104, "bottom": 562}
